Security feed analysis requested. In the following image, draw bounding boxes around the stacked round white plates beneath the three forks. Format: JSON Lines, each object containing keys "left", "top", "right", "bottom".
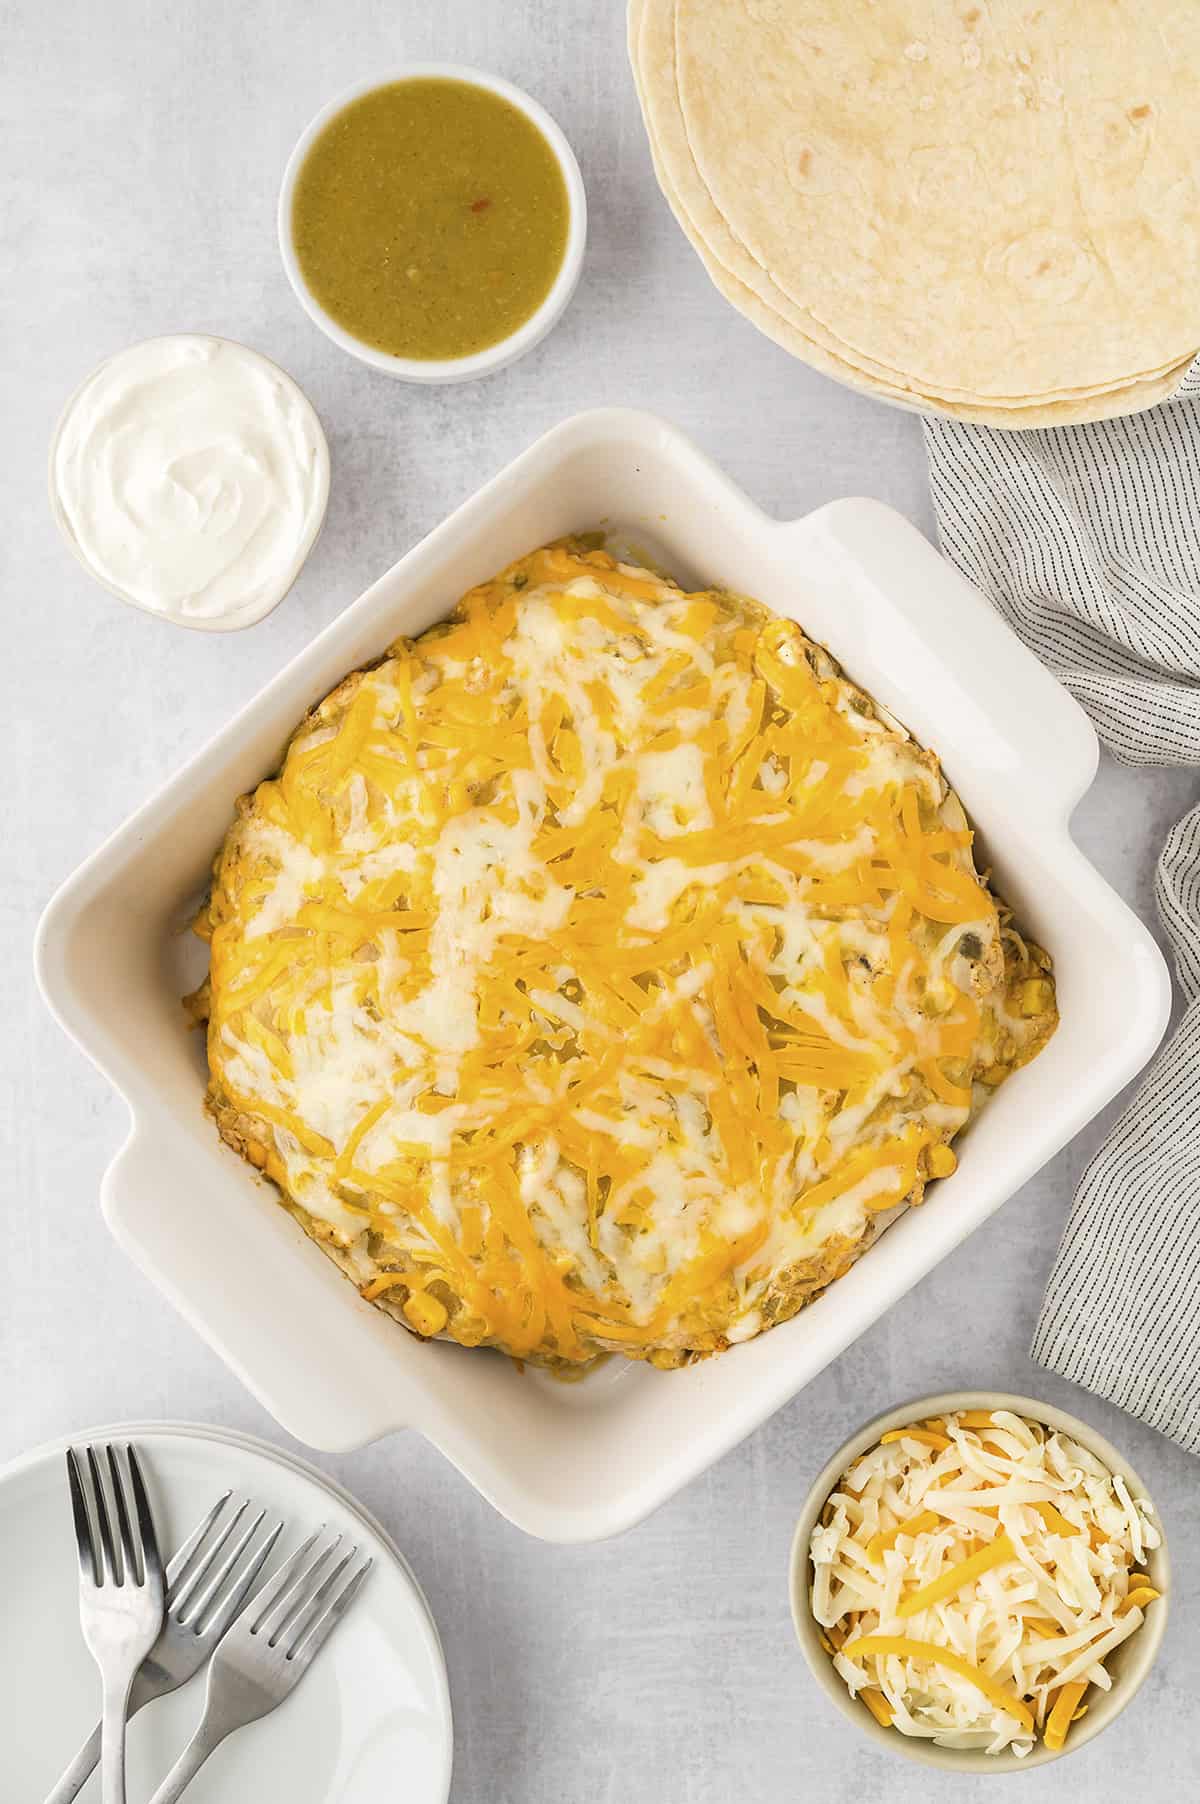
{"left": 0, "top": 1423, "right": 453, "bottom": 1804}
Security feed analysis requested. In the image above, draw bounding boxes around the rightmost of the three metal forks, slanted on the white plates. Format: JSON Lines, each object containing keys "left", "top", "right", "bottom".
{"left": 152, "top": 1532, "right": 372, "bottom": 1804}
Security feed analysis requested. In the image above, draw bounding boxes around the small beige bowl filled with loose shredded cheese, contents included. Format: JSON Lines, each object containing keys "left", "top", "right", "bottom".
{"left": 792, "top": 1391, "right": 1169, "bottom": 1773}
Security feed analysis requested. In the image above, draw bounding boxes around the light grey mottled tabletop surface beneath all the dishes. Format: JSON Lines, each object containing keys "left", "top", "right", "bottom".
{"left": 0, "top": 0, "right": 1200, "bottom": 1804}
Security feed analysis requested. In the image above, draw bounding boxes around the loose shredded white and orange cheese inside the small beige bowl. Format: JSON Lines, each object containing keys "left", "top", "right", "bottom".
{"left": 810, "top": 1411, "right": 1160, "bottom": 1755}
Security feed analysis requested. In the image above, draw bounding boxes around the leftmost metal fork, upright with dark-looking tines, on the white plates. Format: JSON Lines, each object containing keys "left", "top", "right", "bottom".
{"left": 67, "top": 1445, "right": 162, "bottom": 1804}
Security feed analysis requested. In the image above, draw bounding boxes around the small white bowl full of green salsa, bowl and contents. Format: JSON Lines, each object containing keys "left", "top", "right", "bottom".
{"left": 278, "top": 63, "right": 586, "bottom": 382}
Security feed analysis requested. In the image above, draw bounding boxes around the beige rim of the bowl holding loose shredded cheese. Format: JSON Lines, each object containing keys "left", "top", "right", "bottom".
{"left": 789, "top": 1391, "right": 1171, "bottom": 1777}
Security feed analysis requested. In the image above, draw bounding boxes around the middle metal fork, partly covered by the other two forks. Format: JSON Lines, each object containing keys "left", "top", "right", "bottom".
{"left": 45, "top": 1492, "right": 283, "bottom": 1804}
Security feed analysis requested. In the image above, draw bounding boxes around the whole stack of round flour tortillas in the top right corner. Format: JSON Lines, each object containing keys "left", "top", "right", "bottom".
{"left": 630, "top": 0, "right": 1200, "bottom": 428}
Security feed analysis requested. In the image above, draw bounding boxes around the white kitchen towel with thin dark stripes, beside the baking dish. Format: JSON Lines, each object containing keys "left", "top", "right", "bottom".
{"left": 924, "top": 369, "right": 1200, "bottom": 1452}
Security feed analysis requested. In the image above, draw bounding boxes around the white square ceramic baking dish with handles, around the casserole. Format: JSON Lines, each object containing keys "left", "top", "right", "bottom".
{"left": 36, "top": 410, "right": 1169, "bottom": 1541}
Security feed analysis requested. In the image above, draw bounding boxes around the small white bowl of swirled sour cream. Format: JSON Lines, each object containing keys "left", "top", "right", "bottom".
{"left": 51, "top": 334, "right": 328, "bottom": 631}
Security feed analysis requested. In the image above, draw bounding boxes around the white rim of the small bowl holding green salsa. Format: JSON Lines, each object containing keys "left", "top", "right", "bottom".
{"left": 276, "top": 61, "right": 588, "bottom": 382}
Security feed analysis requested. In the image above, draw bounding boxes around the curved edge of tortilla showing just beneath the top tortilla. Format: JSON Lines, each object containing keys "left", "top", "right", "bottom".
{"left": 628, "top": 0, "right": 1189, "bottom": 414}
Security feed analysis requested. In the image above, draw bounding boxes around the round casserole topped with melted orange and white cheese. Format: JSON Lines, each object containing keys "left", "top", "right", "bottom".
{"left": 197, "top": 545, "right": 1056, "bottom": 1366}
